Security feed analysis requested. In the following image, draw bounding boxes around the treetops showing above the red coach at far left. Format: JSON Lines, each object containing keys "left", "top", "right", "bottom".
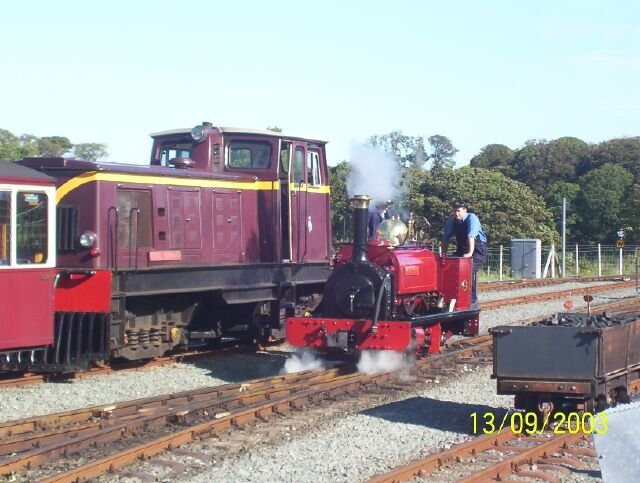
{"left": 0, "top": 129, "right": 109, "bottom": 161}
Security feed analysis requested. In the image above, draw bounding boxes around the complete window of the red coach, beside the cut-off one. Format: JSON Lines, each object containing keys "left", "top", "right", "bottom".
{"left": 16, "top": 191, "right": 49, "bottom": 264}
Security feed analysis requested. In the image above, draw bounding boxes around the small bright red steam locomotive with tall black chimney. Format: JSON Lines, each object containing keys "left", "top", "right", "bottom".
{"left": 287, "top": 195, "right": 480, "bottom": 355}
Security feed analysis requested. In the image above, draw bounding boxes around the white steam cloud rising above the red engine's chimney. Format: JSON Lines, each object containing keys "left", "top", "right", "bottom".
{"left": 347, "top": 143, "right": 400, "bottom": 203}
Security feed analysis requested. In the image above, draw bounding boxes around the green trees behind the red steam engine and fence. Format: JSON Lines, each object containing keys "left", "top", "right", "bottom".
{"left": 330, "top": 131, "right": 640, "bottom": 246}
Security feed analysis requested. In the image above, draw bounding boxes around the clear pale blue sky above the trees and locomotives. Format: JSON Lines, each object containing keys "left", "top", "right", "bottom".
{"left": 0, "top": 0, "right": 640, "bottom": 166}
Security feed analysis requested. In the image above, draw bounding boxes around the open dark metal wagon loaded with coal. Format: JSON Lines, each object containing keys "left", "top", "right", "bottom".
{"left": 491, "top": 314, "right": 640, "bottom": 412}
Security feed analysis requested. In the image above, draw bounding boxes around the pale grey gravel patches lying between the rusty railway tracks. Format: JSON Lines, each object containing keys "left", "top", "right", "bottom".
{"left": 0, "top": 282, "right": 637, "bottom": 482}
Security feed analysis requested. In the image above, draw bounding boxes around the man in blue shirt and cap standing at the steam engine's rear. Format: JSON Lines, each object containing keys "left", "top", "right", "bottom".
{"left": 442, "top": 201, "right": 487, "bottom": 304}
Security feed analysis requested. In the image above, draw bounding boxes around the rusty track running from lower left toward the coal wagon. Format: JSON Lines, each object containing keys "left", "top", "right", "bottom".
{"left": 5, "top": 300, "right": 637, "bottom": 482}
